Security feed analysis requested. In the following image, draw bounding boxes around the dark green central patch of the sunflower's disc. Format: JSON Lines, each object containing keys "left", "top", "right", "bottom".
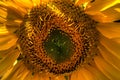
{"left": 43, "top": 29, "right": 74, "bottom": 63}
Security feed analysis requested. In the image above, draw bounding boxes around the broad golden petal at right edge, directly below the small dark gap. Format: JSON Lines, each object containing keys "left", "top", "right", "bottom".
{"left": 97, "top": 23, "right": 120, "bottom": 38}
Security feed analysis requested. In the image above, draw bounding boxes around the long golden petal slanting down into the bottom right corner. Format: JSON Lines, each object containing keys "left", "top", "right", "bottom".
{"left": 94, "top": 56, "right": 120, "bottom": 80}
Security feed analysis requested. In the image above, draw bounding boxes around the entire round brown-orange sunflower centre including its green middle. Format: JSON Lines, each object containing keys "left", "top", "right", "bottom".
{"left": 18, "top": 0, "right": 99, "bottom": 74}
